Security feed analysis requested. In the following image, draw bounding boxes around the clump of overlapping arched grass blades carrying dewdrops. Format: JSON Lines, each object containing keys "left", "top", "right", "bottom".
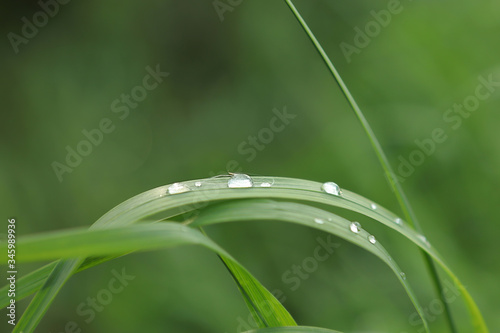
{"left": 0, "top": 176, "right": 486, "bottom": 331}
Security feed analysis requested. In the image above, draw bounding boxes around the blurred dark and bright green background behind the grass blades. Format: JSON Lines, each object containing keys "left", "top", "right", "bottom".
{"left": 0, "top": 0, "right": 500, "bottom": 333}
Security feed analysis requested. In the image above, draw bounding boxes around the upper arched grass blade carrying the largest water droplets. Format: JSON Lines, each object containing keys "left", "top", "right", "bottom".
{"left": 3, "top": 177, "right": 487, "bottom": 332}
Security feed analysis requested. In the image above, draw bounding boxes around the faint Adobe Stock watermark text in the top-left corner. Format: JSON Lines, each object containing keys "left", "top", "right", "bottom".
{"left": 7, "top": 0, "right": 70, "bottom": 54}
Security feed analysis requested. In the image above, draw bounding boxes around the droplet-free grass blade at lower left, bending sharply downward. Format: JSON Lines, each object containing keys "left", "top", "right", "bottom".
{"left": 0, "top": 223, "right": 296, "bottom": 331}
